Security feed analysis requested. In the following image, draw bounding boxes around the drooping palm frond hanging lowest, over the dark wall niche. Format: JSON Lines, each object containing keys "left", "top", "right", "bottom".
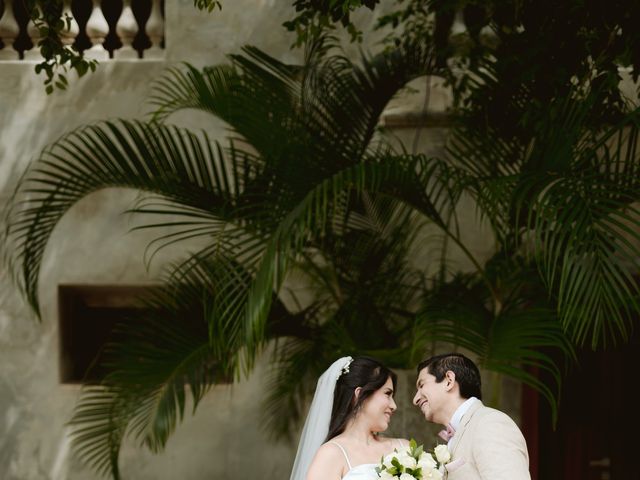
{"left": 70, "top": 260, "right": 216, "bottom": 479}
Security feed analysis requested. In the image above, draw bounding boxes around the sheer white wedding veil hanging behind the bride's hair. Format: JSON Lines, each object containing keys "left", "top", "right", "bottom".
{"left": 290, "top": 357, "right": 353, "bottom": 480}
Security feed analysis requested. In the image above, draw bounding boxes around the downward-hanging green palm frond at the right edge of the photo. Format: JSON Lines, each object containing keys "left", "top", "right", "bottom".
{"left": 532, "top": 174, "right": 640, "bottom": 347}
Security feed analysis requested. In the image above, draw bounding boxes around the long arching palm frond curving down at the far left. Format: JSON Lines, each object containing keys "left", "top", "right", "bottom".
{"left": 6, "top": 121, "right": 248, "bottom": 312}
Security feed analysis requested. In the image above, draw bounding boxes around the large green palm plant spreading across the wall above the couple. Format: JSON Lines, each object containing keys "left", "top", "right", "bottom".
{"left": 1, "top": 31, "right": 638, "bottom": 478}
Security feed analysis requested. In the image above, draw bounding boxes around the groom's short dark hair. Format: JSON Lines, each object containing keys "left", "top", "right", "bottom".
{"left": 418, "top": 353, "right": 482, "bottom": 400}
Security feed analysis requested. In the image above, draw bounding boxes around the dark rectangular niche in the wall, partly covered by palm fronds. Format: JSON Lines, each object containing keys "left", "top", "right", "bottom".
{"left": 58, "top": 285, "right": 155, "bottom": 383}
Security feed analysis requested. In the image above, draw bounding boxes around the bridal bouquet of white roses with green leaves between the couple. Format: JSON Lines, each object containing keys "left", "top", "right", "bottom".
{"left": 376, "top": 439, "right": 451, "bottom": 480}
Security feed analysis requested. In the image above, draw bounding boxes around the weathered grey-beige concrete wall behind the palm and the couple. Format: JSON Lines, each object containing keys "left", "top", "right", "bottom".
{"left": 0, "top": 0, "right": 502, "bottom": 480}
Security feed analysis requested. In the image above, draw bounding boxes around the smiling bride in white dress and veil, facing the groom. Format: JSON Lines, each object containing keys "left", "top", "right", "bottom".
{"left": 290, "top": 357, "right": 408, "bottom": 480}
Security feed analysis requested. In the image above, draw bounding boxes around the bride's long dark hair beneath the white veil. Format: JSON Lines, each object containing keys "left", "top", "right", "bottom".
{"left": 325, "top": 357, "right": 398, "bottom": 441}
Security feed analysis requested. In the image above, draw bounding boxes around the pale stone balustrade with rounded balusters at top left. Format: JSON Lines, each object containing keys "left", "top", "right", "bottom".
{"left": 0, "top": 0, "right": 164, "bottom": 61}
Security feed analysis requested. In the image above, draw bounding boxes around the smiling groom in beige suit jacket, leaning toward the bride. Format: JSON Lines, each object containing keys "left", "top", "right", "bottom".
{"left": 413, "top": 353, "right": 531, "bottom": 480}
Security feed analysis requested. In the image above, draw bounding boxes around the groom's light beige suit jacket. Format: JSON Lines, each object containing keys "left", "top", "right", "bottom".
{"left": 447, "top": 400, "right": 531, "bottom": 480}
